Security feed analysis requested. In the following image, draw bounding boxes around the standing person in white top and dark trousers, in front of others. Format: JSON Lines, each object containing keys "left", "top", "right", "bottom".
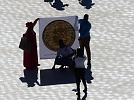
{"left": 74, "top": 48, "right": 87, "bottom": 96}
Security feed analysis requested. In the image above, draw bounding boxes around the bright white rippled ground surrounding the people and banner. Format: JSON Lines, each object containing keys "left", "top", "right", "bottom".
{"left": 0, "top": 0, "right": 134, "bottom": 100}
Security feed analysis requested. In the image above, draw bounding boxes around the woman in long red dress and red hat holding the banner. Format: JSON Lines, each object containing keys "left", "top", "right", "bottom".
{"left": 23, "top": 18, "right": 40, "bottom": 70}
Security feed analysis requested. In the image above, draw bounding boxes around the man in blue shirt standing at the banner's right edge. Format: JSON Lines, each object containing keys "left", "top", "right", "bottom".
{"left": 78, "top": 14, "right": 92, "bottom": 65}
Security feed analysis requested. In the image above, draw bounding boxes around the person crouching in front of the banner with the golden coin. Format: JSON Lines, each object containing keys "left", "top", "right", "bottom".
{"left": 52, "top": 40, "right": 74, "bottom": 70}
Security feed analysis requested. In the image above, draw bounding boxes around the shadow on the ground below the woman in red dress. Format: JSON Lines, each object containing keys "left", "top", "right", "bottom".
{"left": 19, "top": 68, "right": 39, "bottom": 87}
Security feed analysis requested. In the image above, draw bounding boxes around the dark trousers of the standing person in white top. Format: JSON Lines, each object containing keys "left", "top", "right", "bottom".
{"left": 74, "top": 68, "right": 87, "bottom": 92}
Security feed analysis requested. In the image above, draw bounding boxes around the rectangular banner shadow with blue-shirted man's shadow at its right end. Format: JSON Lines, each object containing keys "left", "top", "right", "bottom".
{"left": 40, "top": 68, "right": 92, "bottom": 86}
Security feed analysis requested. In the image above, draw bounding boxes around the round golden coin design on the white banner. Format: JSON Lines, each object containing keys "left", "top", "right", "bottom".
{"left": 42, "top": 20, "right": 76, "bottom": 52}
